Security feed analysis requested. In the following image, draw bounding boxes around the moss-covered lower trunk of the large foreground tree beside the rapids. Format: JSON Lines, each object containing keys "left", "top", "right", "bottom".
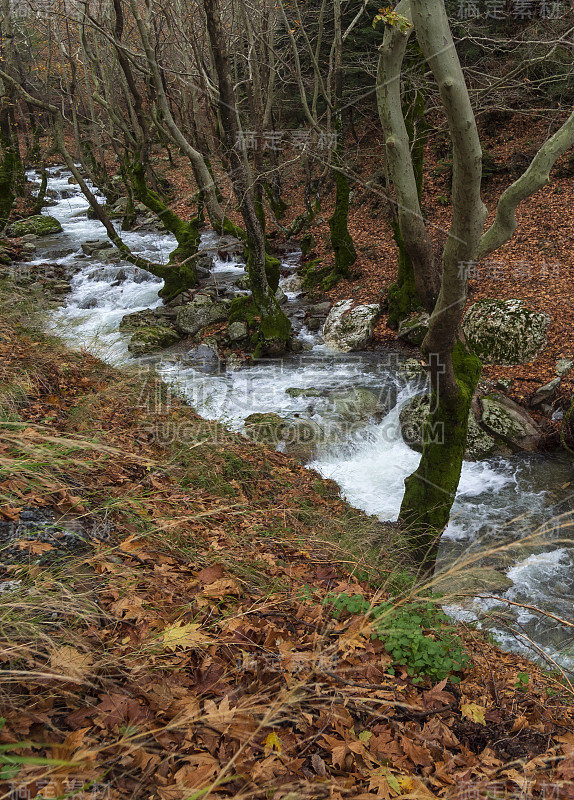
{"left": 399, "top": 341, "right": 482, "bottom": 572}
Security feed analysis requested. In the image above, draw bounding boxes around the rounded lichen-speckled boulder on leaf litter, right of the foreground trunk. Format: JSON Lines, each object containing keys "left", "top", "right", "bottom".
{"left": 463, "top": 300, "right": 551, "bottom": 366}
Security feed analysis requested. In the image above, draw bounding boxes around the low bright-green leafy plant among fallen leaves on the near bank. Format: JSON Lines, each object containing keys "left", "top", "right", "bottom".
{"left": 323, "top": 593, "right": 469, "bottom": 682}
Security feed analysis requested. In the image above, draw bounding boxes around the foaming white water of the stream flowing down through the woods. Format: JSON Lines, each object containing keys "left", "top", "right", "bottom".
{"left": 22, "top": 169, "right": 574, "bottom": 670}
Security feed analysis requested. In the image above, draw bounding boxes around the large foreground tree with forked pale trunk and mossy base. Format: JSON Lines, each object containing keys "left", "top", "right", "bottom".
{"left": 377, "top": 0, "right": 574, "bottom": 569}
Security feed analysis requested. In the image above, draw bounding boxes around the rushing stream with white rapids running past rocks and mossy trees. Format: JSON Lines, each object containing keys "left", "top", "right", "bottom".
{"left": 3, "top": 164, "right": 574, "bottom": 666}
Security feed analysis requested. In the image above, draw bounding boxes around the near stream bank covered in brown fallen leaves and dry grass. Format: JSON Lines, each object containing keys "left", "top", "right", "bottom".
{"left": 0, "top": 276, "right": 574, "bottom": 800}
